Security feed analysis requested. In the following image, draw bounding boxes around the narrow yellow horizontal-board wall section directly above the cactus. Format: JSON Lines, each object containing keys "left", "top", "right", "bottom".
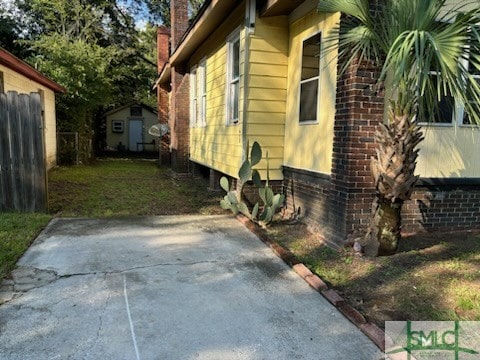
{"left": 247, "top": 16, "right": 288, "bottom": 180}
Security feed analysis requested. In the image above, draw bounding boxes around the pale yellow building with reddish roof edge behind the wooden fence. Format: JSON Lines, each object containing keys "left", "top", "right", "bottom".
{"left": 0, "top": 48, "right": 65, "bottom": 168}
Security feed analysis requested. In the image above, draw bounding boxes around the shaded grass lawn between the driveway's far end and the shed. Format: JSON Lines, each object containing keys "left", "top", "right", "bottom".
{"left": 49, "top": 159, "right": 223, "bottom": 217}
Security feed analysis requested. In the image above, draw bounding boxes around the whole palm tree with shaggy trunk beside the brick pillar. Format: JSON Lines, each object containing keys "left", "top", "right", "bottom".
{"left": 318, "top": 0, "right": 480, "bottom": 255}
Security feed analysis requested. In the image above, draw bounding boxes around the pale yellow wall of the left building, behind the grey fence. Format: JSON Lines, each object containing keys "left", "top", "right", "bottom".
{"left": 0, "top": 65, "right": 57, "bottom": 168}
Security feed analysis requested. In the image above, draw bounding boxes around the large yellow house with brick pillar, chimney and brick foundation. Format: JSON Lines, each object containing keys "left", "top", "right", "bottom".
{"left": 157, "top": 0, "right": 480, "bottom": 244}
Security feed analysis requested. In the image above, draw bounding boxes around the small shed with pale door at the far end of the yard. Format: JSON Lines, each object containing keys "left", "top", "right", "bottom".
{"left": 105, "top": 103, "right": 158, "bottom": 152}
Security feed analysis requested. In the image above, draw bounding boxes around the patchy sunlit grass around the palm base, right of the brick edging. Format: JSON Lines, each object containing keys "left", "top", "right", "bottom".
{"left": 268, "top": 223, "right": 480, "bottom": 327}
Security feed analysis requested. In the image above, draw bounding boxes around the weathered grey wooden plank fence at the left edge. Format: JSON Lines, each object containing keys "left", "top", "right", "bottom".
{"left": 0, "top": 91, "right": 48, "bottom": 212}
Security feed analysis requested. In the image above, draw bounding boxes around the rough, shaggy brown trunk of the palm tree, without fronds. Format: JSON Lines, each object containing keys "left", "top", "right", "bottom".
{"left": 363, "top": 95, "right": 423, "bottom": 256}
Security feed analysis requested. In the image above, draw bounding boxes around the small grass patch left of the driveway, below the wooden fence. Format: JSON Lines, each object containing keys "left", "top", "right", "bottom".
{"left": 0, "top": 213, "right": 51, "bottom": 279}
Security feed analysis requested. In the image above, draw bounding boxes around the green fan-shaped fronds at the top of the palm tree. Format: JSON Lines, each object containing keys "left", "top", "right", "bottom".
{"left": 318, "top": 0, "right": 480, "bottom": 124}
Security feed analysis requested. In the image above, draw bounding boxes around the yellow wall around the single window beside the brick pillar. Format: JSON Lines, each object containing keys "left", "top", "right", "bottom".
{"left": 285, "top": 10, "right": 339, "bottom": 174}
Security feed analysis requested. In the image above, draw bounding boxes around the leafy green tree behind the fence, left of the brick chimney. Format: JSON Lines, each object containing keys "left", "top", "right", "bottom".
{"left": 12, "top": 0, "right": 156, "bottom": 159}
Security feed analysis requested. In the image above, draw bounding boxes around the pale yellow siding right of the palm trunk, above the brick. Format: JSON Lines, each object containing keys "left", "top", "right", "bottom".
{"left": 416, "top": 125, "right": 480, "bottom": 178}
